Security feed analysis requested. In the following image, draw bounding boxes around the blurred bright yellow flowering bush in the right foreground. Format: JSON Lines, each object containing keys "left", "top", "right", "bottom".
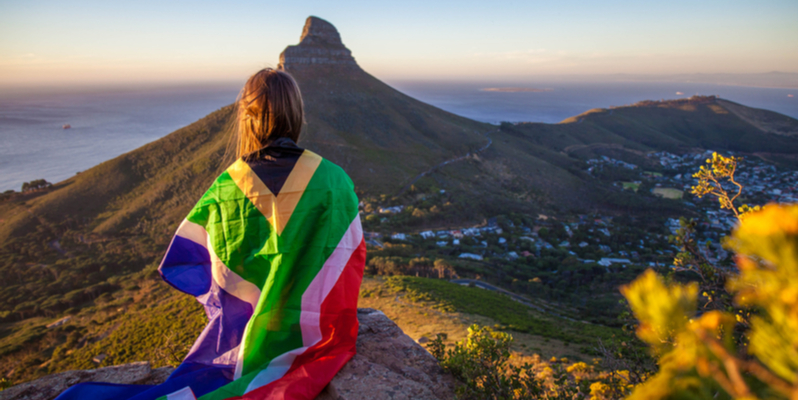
{"left": 622, "top": 204, "right": 798, "bottom": 399}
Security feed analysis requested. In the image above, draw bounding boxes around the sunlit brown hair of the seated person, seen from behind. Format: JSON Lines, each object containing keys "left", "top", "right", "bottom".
{"left": 231, "top": 68, "right": 304, "bottom": 158}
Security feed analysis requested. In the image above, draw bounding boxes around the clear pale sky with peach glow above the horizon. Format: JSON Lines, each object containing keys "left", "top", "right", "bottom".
{"left": 0, "top": 0, "right": 798, "bottom": 84}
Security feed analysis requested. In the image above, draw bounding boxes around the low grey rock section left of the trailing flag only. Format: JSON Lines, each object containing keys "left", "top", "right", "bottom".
{"left": 0, "top": 361, "right": 161, "bottom": 400}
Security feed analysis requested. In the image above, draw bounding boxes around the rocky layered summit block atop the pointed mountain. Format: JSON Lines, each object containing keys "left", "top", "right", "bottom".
{"left": 278, "top": 16, "right": 359, "bottom": 71}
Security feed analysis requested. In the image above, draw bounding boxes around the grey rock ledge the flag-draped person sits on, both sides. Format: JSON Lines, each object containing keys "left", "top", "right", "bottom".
{"left": 0, "top": 308, "right": 454, "bottom": 400}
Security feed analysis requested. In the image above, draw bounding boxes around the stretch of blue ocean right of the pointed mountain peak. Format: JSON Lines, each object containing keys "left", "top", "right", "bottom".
{"left": 390, "top": 81, "right": 797, "bottom": 124}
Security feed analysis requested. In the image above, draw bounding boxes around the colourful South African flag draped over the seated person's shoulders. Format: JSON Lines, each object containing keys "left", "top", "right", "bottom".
{"left": 59, "top": 138, "right": 366, "bottom": 400}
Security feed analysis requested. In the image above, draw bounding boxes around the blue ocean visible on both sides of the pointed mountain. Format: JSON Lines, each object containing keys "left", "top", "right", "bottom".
{"left": 0, "top": 81, "right": 798, "bottom": 191}
